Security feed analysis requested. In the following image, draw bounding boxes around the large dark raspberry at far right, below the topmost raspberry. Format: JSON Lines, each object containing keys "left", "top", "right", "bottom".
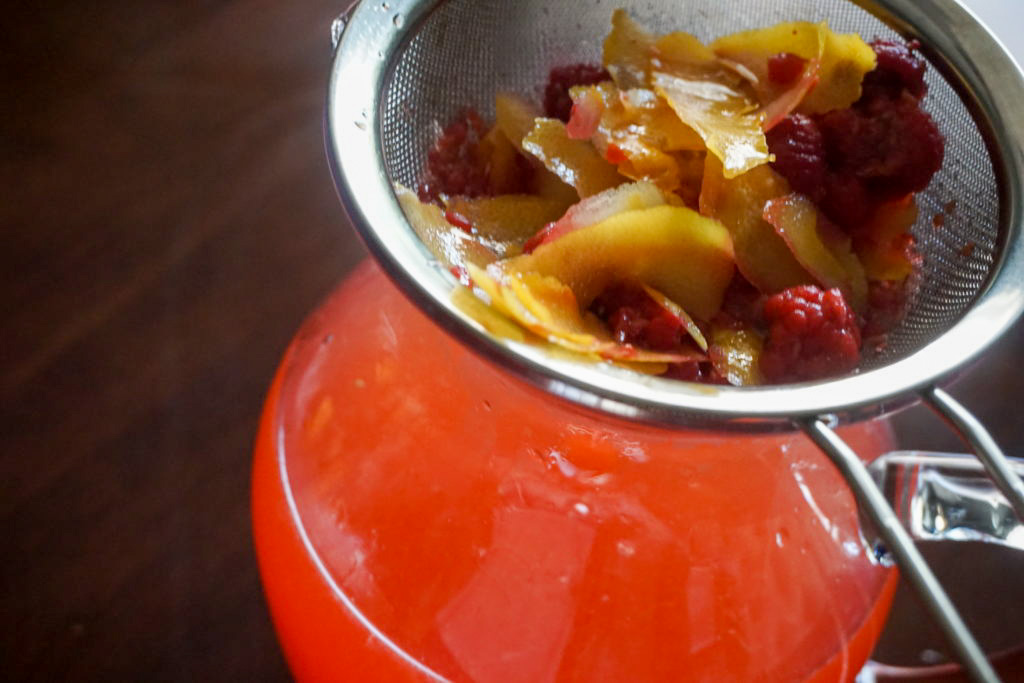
{"left": 818, "top": 95, "right": 945, "bottom": 200}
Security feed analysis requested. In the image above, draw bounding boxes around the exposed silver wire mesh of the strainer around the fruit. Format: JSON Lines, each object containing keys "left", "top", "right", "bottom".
{"left": 380, "top": 0, "right": 999, "bottom": 369}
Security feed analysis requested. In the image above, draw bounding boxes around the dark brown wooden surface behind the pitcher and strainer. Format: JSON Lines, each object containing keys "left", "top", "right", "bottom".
{"left": 0, "top": 0, "right": 1024, "bottom": 681}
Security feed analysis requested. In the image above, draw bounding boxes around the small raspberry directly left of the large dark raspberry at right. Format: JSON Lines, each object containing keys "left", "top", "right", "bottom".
{"left": 766, "top": 114, "right": 826, "bottom": 203}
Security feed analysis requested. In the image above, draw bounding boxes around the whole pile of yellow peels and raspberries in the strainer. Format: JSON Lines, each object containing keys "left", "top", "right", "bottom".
{"left": 396, "top": 10, "right": 943, "bottom": 385}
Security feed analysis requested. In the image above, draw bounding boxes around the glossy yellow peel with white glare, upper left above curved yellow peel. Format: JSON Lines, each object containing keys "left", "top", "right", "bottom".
{"left": 522, "top": 118, "right": 625, "bottom": 198}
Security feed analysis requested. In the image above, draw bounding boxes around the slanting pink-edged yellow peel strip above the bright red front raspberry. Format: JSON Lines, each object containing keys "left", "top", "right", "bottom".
{"left": 764, "top": 194, "right": 867, "bottom": 311}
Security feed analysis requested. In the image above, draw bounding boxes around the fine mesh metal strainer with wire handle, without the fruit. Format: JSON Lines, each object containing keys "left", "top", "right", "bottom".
{"left": 327, "top": 0, "right": 1024, "bottom": 680}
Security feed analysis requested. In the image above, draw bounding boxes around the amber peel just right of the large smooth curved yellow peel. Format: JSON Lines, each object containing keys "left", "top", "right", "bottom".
{"left": 700, "top": 156, "right": 814, "bottom": 294}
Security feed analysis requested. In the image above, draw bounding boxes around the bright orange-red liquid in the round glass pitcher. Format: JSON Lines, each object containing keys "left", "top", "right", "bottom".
{"left": 253, "top": 266, "right": 896, "bottom": 681}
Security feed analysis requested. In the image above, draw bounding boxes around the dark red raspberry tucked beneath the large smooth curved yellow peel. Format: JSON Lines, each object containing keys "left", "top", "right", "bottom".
{"left": 591, "top": 284, "right": 688, "bottom": 351}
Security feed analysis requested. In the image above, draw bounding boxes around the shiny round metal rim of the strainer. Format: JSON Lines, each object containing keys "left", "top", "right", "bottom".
{"left": 326, "top": 0, "right": 1024, "bottom": 431}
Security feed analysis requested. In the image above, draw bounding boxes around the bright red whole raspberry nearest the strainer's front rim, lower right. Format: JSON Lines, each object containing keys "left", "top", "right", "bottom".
{"left": 761, "top": 285, "right": 860, "bottom": 383}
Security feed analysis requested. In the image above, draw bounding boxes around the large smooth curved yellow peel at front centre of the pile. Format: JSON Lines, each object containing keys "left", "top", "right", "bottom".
{"left": 503, "top": 206, "right": 733, "bottom": 319}
